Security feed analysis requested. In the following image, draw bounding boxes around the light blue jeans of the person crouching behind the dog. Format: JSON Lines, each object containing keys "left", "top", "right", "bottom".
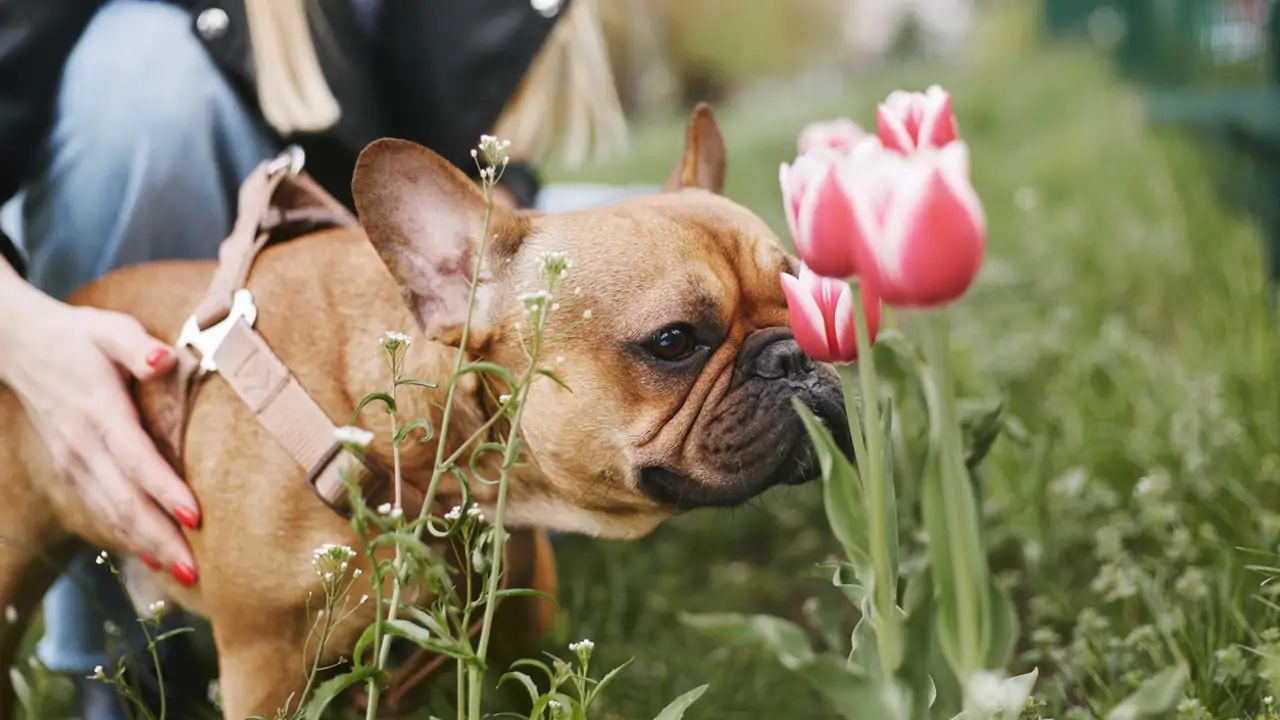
{"left": 0, "top": 0, "right": 660, "bottom": 675}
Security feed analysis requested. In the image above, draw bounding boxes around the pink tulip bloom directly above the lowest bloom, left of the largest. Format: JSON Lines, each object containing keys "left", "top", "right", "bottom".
{"left": 778, "top": 149, "right": 856, "bottom": 278}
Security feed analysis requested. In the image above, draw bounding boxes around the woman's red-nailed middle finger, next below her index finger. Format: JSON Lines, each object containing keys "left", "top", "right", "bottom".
{"left": 79, "top": 427, "right": 196, "bottom": 585}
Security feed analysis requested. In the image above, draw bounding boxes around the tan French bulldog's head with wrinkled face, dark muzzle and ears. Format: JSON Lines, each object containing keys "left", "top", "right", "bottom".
{"left": 355, "top": 108, "right": 847, "bottom": 537}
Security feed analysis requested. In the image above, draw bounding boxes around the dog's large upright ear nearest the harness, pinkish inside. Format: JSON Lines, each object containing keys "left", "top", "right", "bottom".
{"left": 351, "top": 138, "right": 529, "bottom": 346}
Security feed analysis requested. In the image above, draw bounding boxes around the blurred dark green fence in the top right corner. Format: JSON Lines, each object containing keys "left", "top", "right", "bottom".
{"left": 1044, "top": 0, "right": 1280, "bottom": 287}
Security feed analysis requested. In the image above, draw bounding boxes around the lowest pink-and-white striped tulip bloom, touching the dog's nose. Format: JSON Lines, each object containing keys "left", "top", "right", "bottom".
{"left": 781, "top": 263, "right": 881, "bottom": 363}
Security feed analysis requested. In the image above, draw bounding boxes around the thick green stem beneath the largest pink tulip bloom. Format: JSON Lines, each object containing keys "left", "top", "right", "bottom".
{"left": 925, "top": 309, "right": 986, "bottom": 682}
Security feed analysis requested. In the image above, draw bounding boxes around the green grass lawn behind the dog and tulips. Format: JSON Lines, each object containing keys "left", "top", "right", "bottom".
{"left": 17, "top": 1, "right": 1280, "bottom": 720}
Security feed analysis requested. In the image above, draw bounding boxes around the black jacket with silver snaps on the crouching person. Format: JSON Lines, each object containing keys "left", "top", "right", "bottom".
{"left": 0, "top": 0, "right": 567, "bottom": 274}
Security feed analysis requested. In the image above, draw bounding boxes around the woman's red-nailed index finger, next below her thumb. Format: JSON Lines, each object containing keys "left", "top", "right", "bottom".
{"left": 100, "top": 392, "right": 200, "bottom": 529}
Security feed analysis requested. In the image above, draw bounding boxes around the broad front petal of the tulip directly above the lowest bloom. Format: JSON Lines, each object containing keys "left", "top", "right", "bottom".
{"left": 796, "top": 165, "right": 856, "bottom": 278}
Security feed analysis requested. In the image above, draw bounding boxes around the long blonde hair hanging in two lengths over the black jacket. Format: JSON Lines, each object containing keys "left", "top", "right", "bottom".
{"left": 244, "top": 0, "right": 627, "bottom": 167}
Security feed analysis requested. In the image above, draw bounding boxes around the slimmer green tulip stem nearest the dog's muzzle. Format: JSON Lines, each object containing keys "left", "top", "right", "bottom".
{"left": 850, "top": 281, "right": 899, "bottom": 678}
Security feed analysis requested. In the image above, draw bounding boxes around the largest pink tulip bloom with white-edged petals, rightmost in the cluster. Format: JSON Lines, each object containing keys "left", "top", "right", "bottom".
{"left": 840, "top": 141, "right": 987, "bottom": 307}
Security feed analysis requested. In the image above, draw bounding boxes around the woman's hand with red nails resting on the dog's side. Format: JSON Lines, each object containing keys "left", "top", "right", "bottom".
{"left": 0, "top": 274, "right": 200, "bottom": 585}
